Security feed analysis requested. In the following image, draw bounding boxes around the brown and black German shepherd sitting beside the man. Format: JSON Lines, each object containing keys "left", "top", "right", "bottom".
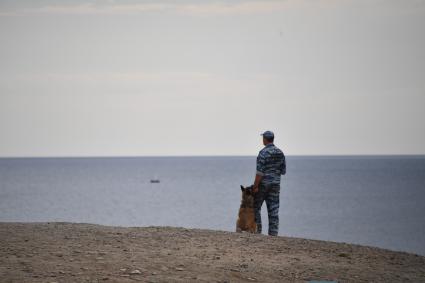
{"left": 236, "top": 185, "right": 257, "bottom": 233}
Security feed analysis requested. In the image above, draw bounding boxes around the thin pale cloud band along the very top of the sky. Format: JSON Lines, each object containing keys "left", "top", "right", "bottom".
{"left": 0, "top": 0, "right": 425, "bottom": 17}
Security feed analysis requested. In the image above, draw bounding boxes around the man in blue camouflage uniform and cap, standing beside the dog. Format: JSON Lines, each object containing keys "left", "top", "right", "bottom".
{"left": 253, "top": 131, "right": 286, "bottom": 236}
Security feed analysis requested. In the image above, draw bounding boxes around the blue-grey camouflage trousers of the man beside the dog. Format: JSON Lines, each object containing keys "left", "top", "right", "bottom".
{"left": 254, "top": 185, "right": 280, "bottom": 236}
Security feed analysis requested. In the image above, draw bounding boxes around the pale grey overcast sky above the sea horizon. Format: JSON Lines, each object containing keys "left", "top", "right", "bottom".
{"left": 0, "top": 0, "right": 425, "bottom": 156}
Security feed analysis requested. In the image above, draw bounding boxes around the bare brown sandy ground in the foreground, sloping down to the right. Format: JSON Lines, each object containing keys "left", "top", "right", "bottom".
{"left": 0, "top": 223, "right": 425, "bottom": 282}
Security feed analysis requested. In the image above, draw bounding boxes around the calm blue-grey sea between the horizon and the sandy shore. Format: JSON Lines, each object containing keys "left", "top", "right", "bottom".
{"left": 0, "top": 156, "right": 425, "bottom": 255}
